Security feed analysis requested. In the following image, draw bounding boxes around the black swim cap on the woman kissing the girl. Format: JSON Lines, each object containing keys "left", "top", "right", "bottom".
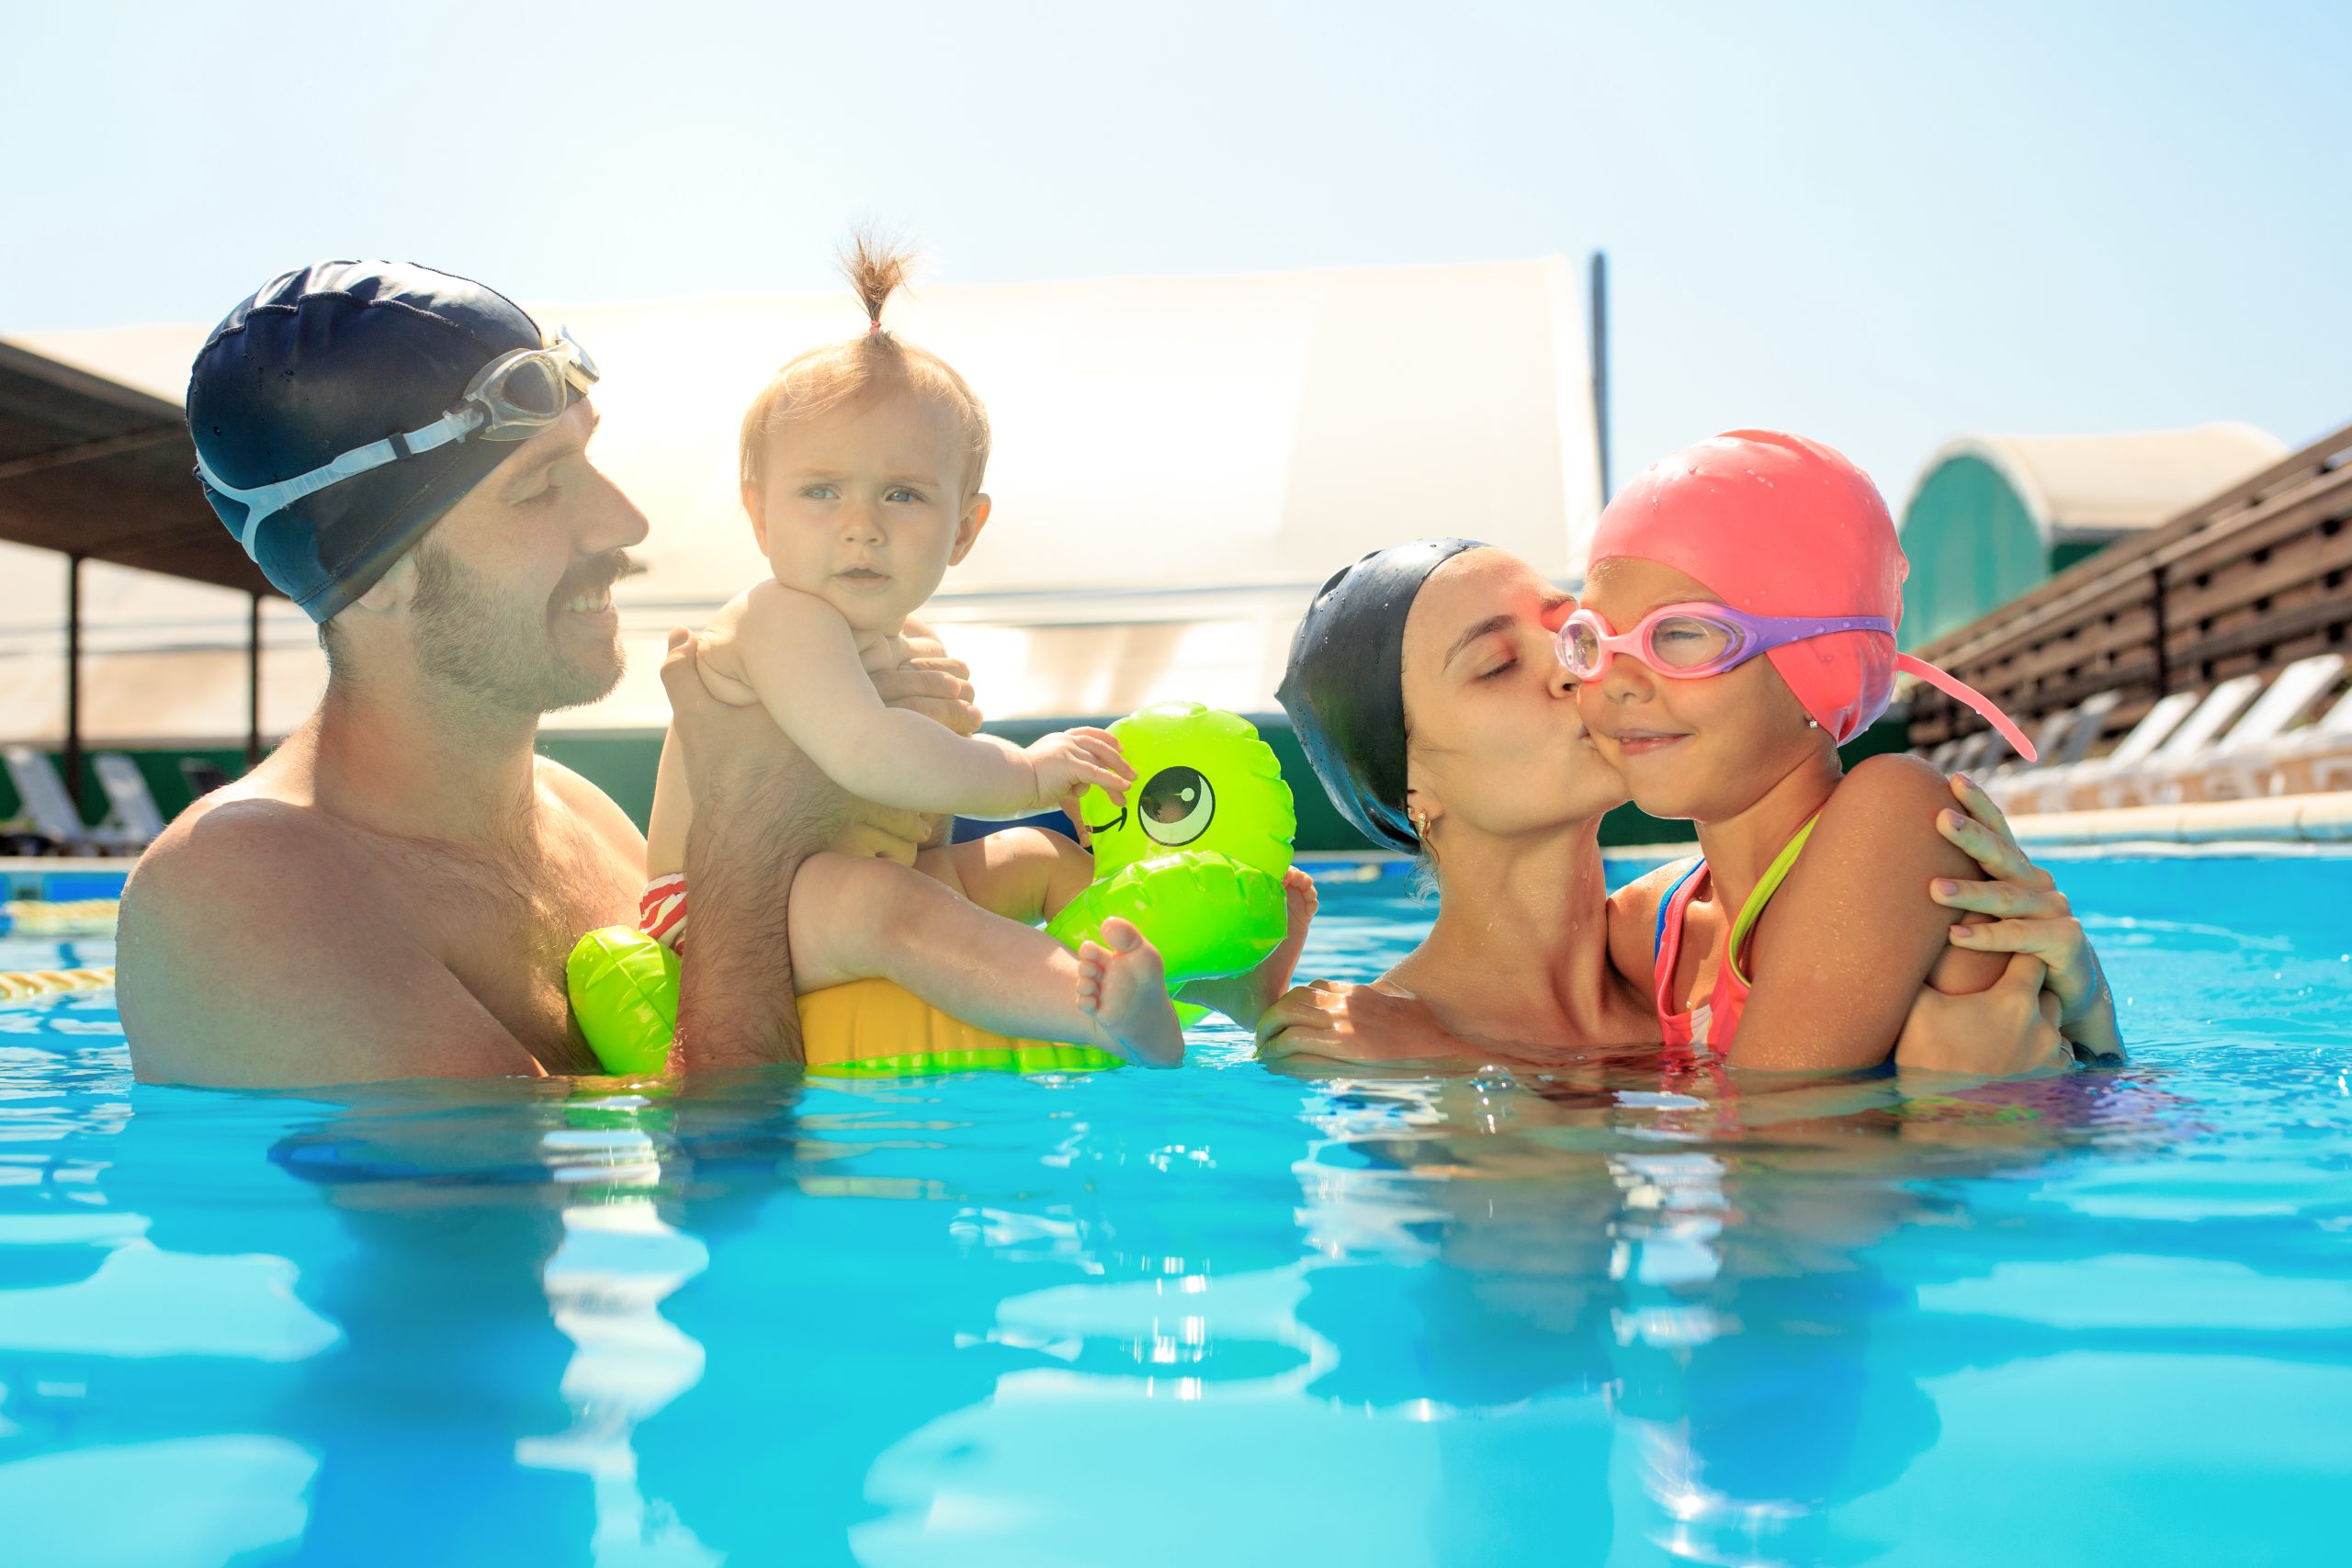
{"left": 1275, "top": 538, "right": 1479, "bottom": 851}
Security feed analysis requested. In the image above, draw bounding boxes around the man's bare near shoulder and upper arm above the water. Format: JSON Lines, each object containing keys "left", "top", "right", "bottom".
{"left": 115, "top": 802, "right": 543, "bottom": 1089}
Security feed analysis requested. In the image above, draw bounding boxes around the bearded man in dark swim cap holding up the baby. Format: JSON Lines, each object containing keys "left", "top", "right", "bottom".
{"left": 118, "top": 261, "right": 978, "bottom": 1086}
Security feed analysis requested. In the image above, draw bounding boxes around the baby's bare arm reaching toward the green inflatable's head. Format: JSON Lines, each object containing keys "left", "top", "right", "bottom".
{"left": 734, "top": 583, "right": 1129, "bottom": 816}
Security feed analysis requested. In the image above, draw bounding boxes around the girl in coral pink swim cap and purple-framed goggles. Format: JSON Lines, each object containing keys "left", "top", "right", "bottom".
{"left": 1559, "top": 430, "right": 2120, "bottom": 1069}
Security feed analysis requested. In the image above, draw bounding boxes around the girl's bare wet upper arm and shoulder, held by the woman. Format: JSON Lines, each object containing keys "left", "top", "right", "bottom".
{"left": 1731, "top": 757, "right": 2007, "bottom": 1072}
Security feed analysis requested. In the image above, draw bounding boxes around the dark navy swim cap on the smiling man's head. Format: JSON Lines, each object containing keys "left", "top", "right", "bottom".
{"left": 188, "top": 261, "right": 541, "bottom": 621}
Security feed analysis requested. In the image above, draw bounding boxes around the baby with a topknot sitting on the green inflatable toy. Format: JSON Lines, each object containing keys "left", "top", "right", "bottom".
{"left": 644, "top": 237, "right": 1183, "bottom": 1067}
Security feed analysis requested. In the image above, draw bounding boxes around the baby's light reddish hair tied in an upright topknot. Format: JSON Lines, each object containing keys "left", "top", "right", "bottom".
{"left": 739, "top": 228, "right": 988, "bottom": 499}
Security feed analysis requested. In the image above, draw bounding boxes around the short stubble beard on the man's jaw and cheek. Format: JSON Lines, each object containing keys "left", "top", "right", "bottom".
{"left": 409, "top": 543, "right": 628, "bottom": 715}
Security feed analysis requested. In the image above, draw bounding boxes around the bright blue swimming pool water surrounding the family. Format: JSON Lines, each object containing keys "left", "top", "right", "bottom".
{"left": 0, "top": 861, "right": 2352, "bottom": 1568}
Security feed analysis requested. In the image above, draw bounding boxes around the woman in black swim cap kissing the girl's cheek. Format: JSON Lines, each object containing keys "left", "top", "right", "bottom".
{"left": 1259, "top": 538, "right": 2120, "bottom": 1075}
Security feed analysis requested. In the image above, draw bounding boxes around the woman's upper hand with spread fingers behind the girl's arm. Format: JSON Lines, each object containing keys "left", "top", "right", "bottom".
{"left": 1905, "top": 773, "right": 2124, "bottom": 1055}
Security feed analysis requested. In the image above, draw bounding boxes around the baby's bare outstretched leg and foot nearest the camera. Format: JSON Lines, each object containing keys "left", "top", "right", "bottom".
{"left": 788, "top": 853, "right": 1183, "bottom": 1067}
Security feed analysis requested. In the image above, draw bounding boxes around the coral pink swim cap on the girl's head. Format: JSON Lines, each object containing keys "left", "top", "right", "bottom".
{"left": 1588, "top": 430, "right": 2034, "bottom": 761}
